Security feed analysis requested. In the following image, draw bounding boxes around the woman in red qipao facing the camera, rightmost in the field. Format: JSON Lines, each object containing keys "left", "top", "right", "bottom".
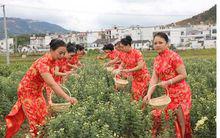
{"left": 143, "top": 32, "right": 191, "bottom": 138}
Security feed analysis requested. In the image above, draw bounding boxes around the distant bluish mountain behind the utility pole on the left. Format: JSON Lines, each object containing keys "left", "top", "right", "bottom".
{"left": 0, "top": 18, "right": 69, "bottom": 38}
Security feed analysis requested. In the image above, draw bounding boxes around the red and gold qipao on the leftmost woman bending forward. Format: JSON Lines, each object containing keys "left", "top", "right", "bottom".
{"left": 5, "top": 54, "right": 55, "bottom": 138}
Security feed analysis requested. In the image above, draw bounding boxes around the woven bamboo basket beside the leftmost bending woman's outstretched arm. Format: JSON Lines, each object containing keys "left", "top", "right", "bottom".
{"left": 50, "top": 85, "right": 71, "bottom": 112}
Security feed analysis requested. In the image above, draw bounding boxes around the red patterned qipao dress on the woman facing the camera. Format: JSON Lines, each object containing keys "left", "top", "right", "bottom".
{"left": 153, "top": 49, "right": 192, "bottom": 138}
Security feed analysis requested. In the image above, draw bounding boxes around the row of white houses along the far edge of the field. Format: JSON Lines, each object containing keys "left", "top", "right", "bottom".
{"left": 0, "top": 25, "right": 217, "bottom": 51}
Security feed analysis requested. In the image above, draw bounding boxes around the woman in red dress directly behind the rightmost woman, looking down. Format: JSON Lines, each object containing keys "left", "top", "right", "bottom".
{"left": 119, "top": 36, "right": 150, "bottom": 101}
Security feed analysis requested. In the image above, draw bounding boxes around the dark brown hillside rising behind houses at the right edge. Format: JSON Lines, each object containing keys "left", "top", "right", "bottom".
{"left": 171, "top": 5, "right": 216, "bottom": 26}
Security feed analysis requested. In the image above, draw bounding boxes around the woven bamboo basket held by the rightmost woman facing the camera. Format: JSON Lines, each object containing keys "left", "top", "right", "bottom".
{"left": 149, "top": 84, "right": 171, "bottom": 110}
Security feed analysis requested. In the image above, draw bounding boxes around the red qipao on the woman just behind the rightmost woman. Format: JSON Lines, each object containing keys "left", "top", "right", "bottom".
{"left": 120, "top": 49, "right": 150, "bottom": 100}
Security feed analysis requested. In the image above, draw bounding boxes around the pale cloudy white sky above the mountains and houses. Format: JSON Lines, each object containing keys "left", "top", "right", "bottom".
{"left": 0, "top": 0, "right": 217, "bottom": 31}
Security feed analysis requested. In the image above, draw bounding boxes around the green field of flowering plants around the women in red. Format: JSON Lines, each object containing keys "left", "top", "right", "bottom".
{"left": 0, "top": 49, "right": 216, "bottom": 138}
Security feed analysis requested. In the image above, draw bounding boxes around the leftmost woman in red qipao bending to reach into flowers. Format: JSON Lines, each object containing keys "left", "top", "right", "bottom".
{"left": 5, "top": 39, "right": 77, "bottom": 138}
